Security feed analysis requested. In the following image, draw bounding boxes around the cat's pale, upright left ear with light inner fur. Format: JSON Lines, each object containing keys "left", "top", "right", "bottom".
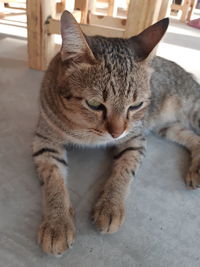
{"left": 61, "top": 10, "right": 96, "bottom": 64}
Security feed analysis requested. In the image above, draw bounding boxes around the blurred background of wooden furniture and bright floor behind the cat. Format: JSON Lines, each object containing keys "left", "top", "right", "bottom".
{"left": 0, "top": 0, "right": 200, "bottom": 76}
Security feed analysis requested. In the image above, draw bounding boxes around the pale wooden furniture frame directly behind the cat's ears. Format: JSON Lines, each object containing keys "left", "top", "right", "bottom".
{"left": 27, "top": 0, "right": 170, "bottom": 70}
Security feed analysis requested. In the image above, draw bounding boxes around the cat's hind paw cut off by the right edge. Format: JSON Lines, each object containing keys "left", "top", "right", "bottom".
{"left": 185, "top": 158, "right": 200, "bottom": 189}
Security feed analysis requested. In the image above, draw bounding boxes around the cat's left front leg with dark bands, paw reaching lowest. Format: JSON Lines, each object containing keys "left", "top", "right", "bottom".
{"left": 33, "top": 134, "right": 75, "bottom": 255}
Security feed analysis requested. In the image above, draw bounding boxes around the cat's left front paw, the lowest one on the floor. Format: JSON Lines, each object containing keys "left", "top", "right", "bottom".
{"left": 38, "top": 214, "right": 75, "bottom": 256}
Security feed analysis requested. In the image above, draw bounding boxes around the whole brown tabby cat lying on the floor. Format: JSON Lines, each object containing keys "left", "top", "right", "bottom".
{"left": 33, "top": 11, "right": 200, "bottom": 255}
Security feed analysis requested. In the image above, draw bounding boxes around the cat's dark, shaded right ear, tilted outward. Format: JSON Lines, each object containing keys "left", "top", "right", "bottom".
{"left": 129, "top": 18, "right": 169, "bottom": 61}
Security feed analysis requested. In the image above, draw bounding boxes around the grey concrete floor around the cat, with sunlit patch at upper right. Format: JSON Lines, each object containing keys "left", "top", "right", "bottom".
{"left": 0, "top": 17, "right": 200, "bottom": 267}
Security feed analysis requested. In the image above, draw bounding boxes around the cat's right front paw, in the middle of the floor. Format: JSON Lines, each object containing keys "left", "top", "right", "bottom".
{"left": 91, "top": 195, "right": 125, "bottom": 234}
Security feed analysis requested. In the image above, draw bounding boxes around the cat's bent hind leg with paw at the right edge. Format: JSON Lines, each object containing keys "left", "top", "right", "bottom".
{"left": 155, "top": 122, "right": 200, "bottom": 189}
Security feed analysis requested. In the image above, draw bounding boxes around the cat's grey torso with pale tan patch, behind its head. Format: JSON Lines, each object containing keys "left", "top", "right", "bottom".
{"left": 146, "top": 57, "right": 200, "bottom": 133}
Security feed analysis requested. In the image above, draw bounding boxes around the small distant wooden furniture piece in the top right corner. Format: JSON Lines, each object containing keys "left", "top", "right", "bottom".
{"left": 171, "top": 0, "right": 197, "bottom": 22}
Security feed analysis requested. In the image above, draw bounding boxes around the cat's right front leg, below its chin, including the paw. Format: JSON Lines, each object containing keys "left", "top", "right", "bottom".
{"left": 92, "top": 135, "right": 146, "bottom": 233}
